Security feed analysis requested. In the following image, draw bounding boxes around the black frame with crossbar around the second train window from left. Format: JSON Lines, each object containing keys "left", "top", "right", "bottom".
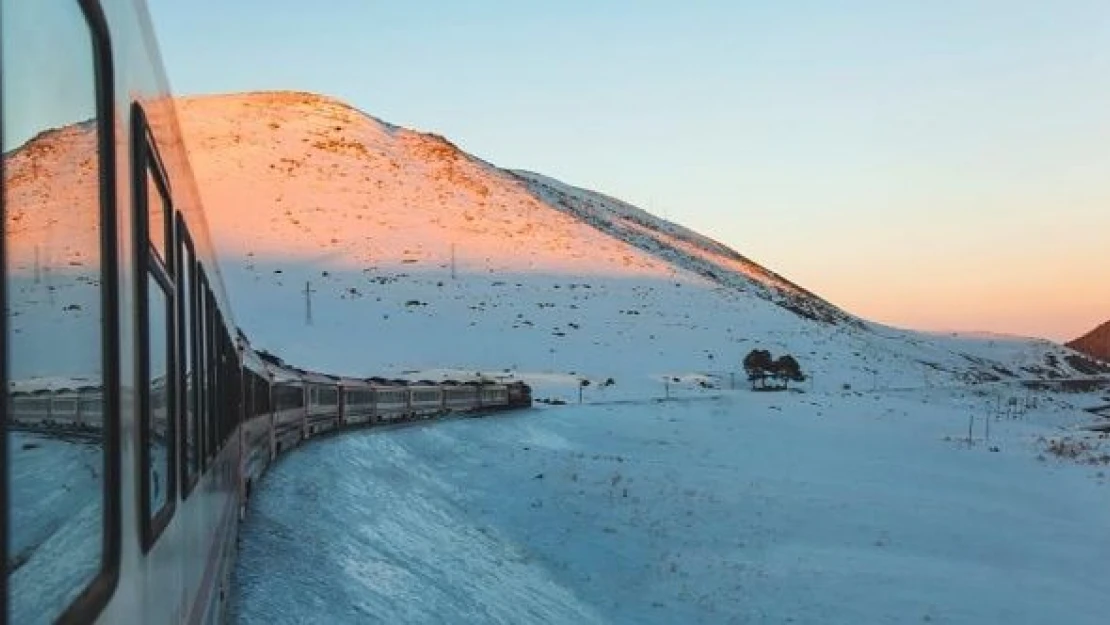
{"left": 131, "top": 102, "right": 178, "bottom": 554}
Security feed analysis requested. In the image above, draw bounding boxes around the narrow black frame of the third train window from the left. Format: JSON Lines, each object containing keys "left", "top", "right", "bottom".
{"left": 174, "top": 212, "right": 204, "bottom": 500}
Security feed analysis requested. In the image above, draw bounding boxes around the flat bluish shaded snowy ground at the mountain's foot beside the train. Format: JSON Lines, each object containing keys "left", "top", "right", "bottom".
{"left": 234, "top": 391, "right": 1110, "bottom": 624}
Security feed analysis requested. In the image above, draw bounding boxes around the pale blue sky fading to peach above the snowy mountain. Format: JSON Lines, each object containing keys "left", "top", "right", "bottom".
{"left": 149, "top": 0, "right": 1110, "bottom": 339}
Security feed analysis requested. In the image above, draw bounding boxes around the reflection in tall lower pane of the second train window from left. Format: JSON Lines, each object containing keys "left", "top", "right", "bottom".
{"left": 147, "top": 274, "right": 172, "bottom": 517}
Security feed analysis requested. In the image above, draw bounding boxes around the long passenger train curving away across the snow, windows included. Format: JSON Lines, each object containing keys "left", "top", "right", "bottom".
{"left": 0, "top": 0, "right": 532, "bottom": 625}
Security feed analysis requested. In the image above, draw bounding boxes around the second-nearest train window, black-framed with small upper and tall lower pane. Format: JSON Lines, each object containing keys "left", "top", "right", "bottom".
{"left": 131, "top": 104, "right": 176, "bottom": 550}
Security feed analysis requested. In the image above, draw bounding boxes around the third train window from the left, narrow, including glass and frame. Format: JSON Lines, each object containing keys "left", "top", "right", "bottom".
{"left": 178, "top": 225, "right": 200, "bottom": 496}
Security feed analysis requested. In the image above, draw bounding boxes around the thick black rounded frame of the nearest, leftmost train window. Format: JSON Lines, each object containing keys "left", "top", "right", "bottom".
{"left": 0, "top": 0, "right": 122, "bottom": 625}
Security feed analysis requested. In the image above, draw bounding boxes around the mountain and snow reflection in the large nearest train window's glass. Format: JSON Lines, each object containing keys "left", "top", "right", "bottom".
{"left": 0, "top": 0, "right": 105, "bottom": 624}
